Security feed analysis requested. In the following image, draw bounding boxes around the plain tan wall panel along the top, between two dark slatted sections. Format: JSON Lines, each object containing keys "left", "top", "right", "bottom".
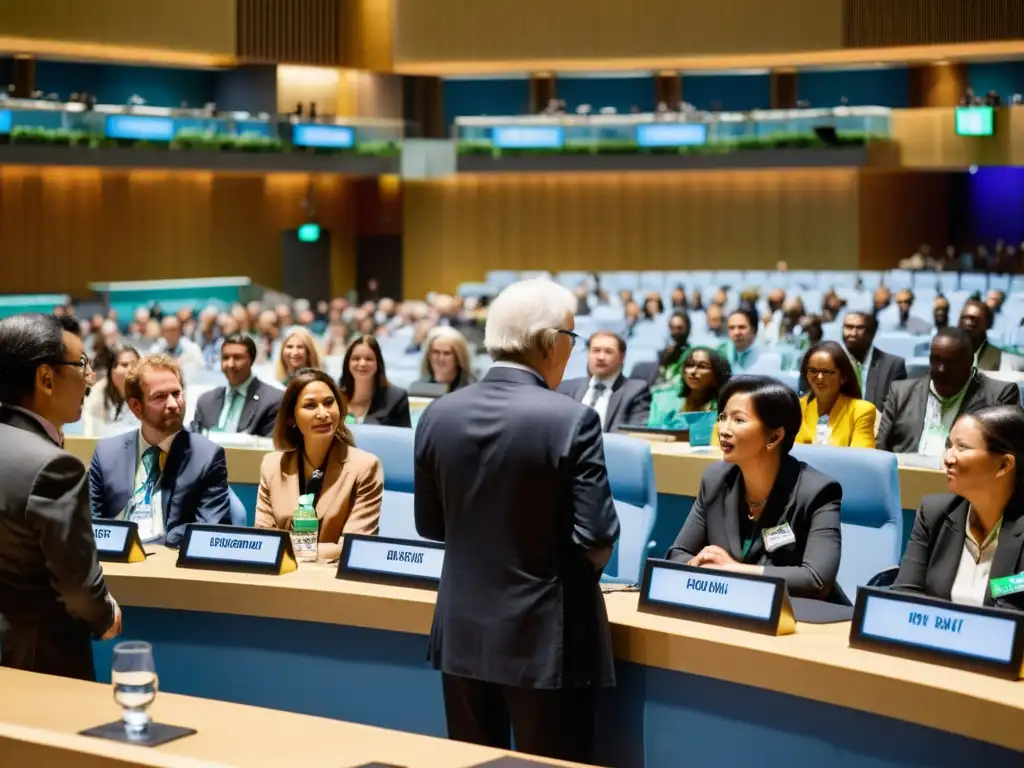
{"left": 394, "top": 0, "right": 842, "bottom": 68}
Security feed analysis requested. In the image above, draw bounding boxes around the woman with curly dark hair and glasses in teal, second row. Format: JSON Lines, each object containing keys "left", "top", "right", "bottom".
{"left": 647, "top": 347, "right": 732, "bottom": 434}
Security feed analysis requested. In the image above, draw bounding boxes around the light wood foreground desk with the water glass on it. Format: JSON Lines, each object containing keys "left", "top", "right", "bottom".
{"left": 0, "top": 659, "right": 589, "bottom": 768}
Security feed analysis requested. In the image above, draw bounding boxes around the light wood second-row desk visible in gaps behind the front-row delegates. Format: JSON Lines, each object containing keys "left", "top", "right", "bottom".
{"left": 66, "top": 437, "right": 946, "bottom": 509}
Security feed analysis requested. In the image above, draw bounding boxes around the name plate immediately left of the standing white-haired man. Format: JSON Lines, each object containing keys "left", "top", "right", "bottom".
{"left": 338, "top": 534, "right": 444, "bottom": 590}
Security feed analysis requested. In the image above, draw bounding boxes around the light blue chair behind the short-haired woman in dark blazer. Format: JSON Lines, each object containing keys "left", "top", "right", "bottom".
{"left": 793, "top": 445, "right": 903, "bottom": 600}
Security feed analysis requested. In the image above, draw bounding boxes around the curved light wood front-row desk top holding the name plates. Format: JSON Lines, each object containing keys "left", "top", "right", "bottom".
{"left": 101, "top": 548, "right": 1024, "bottom": 751}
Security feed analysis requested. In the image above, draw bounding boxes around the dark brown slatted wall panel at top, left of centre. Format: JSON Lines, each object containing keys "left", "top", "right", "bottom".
{"left": 234, "top": 0, "right": 341, "bottom": 67}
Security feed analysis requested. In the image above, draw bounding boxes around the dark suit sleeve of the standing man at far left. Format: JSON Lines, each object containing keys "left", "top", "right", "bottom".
{"left": 26, "top": 454, "right": 114, "bottom": 635}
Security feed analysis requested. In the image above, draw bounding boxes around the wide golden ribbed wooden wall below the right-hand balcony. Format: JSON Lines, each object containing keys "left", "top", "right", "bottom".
{"left": 403, "top": 169, "right": 858, "bottom": 296}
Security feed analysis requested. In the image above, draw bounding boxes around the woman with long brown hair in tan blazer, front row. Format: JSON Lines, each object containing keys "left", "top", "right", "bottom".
{"left": 256, "top": 369, "right": 384, "bottom": 560}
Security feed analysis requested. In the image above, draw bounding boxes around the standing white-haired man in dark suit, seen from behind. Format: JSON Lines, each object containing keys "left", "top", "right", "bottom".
{"left": 416, "top": 280, "right": 618, "bottom": 763}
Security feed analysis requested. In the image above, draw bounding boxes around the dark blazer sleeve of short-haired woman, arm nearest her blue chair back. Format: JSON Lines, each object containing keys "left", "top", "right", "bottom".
{"left": 764, "top": 481, "right": 843, "bottom": 599}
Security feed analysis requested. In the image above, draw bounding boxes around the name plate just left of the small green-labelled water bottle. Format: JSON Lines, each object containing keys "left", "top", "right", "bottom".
{"left": 177, "top": 523, "right": 298, "bottom": 575}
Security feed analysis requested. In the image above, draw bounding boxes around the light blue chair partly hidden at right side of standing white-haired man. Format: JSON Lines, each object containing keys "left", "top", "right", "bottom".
{"left": 602, "top": 434, "right": 666, "bottom": 584}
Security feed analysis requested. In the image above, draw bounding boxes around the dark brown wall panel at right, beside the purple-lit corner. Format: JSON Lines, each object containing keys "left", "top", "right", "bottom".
{"left": 859, "top": 171, "right": 951, "bottom": 269}
